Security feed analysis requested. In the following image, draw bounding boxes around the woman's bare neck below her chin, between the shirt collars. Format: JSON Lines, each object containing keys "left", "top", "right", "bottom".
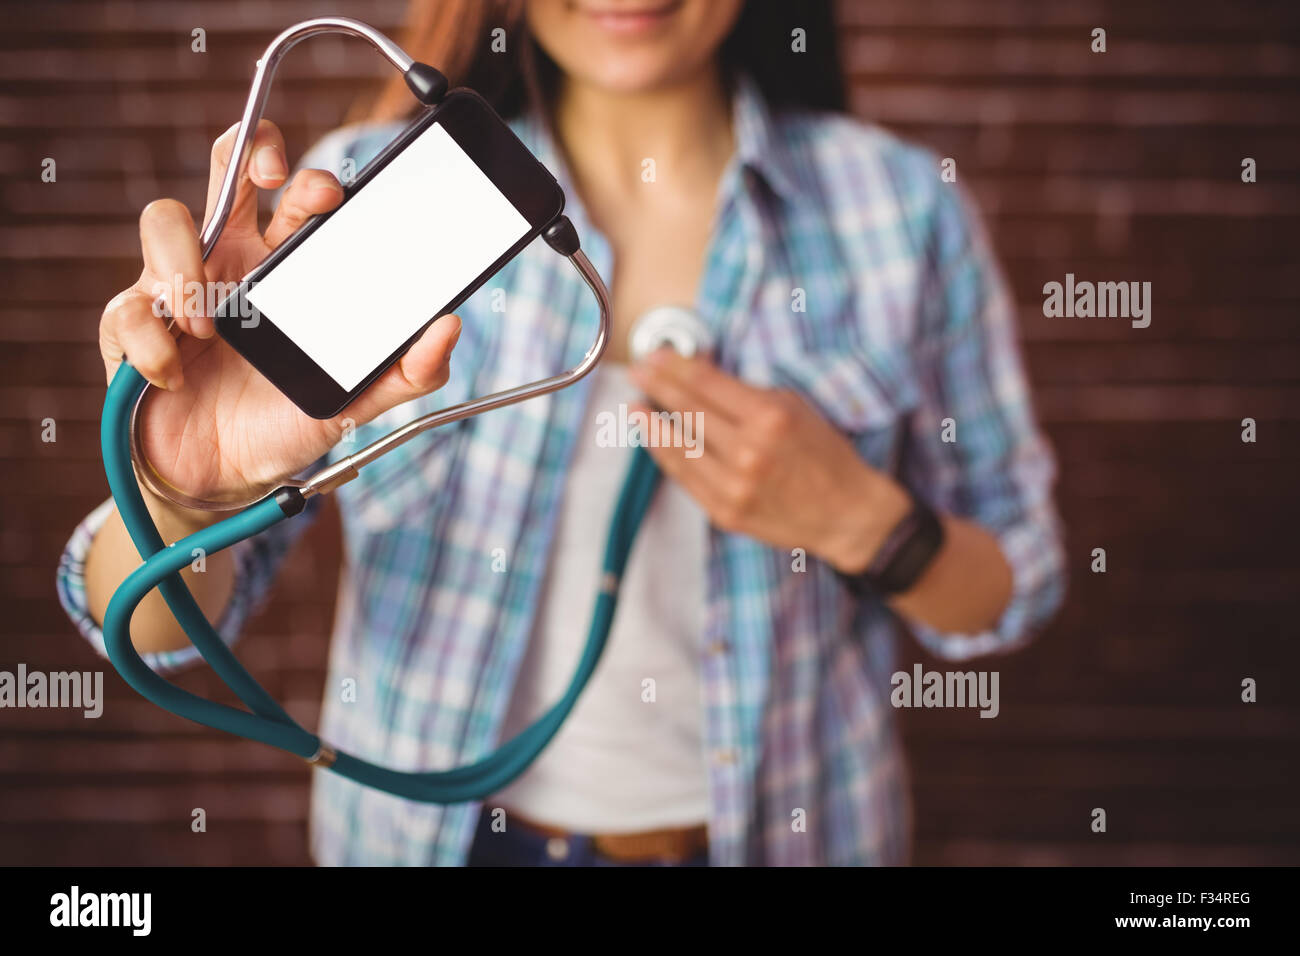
{"left": 555, "top": 66, "right": 735, "bottom": 208}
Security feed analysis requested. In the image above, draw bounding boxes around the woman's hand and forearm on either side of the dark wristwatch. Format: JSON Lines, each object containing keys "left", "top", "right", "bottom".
{"left": 632, "top": 349, "right": 1014, "bottom": 633}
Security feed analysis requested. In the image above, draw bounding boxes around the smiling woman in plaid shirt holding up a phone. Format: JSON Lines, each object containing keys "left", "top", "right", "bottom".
{"left": 61, "top": 0, "right": 1063, "bottom": 865}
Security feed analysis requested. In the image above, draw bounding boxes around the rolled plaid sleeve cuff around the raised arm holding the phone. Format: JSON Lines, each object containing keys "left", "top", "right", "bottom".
{"left": 57, "top": 499, "right": 320, "bottom": 674}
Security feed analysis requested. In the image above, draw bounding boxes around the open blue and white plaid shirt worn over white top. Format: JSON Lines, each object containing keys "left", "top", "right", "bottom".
{"left": 60, "top": 81, "right": 1065, "bottom": 865}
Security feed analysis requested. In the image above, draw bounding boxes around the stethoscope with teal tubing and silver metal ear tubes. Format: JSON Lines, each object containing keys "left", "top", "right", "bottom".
{"left": 100, "top": 17, "right": 710, "bottom": 804}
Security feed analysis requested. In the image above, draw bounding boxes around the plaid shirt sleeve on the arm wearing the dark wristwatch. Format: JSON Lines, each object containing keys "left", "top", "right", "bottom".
{"left": 905, "top": 185, "right": 1066, "bottom": 659}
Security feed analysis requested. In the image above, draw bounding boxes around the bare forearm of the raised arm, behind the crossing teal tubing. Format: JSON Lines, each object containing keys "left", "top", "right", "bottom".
{"left": 86, "top": 490, "right": 234, "bottom": 654}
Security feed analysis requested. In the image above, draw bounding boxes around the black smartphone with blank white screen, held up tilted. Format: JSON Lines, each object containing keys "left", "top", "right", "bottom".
{"left": 213, "top": 90, "right": 564, "bottom": 419}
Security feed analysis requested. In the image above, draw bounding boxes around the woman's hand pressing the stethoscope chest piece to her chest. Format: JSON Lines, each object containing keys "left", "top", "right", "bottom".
{"left": 631, "top": 349, "right": 909, "bottom": 574}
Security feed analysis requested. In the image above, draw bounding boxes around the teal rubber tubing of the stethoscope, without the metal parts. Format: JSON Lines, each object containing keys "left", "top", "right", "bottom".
{"left": 100, "top": 362, "right": 659, "bottom": 804}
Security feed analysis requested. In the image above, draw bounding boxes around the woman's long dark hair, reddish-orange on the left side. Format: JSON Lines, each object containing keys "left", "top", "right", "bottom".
{"left": 359, "top": 0, "right": 845, "bottom": 120}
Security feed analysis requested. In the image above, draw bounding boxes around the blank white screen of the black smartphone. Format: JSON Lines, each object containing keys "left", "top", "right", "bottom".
{"left": 247, "top": 122, "right": 529, "bottom": 392}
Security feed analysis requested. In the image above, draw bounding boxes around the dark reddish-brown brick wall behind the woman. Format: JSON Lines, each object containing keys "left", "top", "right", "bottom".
{"left": 0, "top": 0, "right": 1300, "bottom": 864}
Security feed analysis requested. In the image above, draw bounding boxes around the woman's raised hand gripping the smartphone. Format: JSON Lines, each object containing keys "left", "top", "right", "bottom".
{"left": 99, "top": 120, "right": 460, "bottom": 498}
